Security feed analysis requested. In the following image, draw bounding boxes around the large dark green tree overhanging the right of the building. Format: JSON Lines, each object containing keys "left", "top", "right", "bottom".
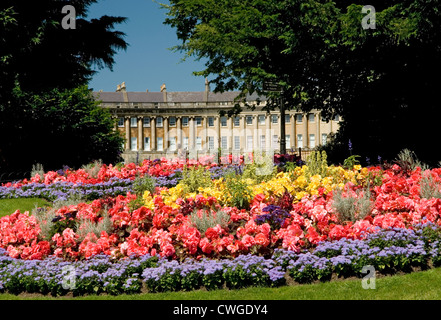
{"left": 165, "top": 0, "right": 441, "bottom": 162}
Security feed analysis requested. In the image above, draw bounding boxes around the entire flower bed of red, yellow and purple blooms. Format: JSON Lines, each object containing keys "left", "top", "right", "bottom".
{"left": 0, "top": 154, "right": 441, "bottom": 294}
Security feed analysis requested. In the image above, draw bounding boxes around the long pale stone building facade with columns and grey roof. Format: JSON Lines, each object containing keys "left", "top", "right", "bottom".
{"left": 94, "top": 83, "right": 340, "bottom": 162}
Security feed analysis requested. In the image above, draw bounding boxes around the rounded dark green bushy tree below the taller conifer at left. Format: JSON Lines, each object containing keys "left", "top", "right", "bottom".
{"left": 4, "top": 86, "right": 123, "bottom": 170}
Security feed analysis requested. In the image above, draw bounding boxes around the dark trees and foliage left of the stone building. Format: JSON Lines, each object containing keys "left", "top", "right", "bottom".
{"left": 0, "top": 0, "right": 127, "bottom": 178}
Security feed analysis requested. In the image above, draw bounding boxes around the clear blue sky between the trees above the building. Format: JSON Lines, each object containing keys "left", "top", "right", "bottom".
{"left": 87, "top": 0, "right": 208, "bottom": 91}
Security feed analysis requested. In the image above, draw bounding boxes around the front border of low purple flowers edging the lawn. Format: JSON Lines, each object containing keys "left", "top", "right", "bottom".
{"left": 0, "top": 224, "right": 441, "bottom": 295}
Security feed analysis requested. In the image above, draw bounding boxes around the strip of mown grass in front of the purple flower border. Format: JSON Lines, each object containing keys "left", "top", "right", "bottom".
{"left": 0, "top": 268, "right": 441, "bottom": 300}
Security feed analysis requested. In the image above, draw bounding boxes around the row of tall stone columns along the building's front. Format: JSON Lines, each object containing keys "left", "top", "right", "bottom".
{"left": 118, "top": 113, "right": 324, "bottom": 151}
